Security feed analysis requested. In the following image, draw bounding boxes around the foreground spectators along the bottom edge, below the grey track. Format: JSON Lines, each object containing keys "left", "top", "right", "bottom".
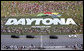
{"left": 1, "top": 44, "right": 83, "bottom": 50}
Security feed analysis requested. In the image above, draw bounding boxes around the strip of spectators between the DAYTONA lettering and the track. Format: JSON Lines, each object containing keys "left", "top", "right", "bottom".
{"left": 1, "top": 23, "right": 83, "bottom": 34}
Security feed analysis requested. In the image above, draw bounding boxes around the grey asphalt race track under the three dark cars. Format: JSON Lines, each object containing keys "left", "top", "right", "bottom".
{"left": 1, "top": 34, "right": 83, "bottom": 47}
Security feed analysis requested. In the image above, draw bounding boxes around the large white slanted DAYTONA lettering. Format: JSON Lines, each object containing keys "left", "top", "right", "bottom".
{"left": 5, "top": 18, "right": 76, "bottom": 25}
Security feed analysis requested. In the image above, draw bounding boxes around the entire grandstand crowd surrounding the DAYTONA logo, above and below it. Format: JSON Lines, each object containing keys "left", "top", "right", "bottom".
{"left": 1, "top": 1, "right": 83, "bottom": 34}
